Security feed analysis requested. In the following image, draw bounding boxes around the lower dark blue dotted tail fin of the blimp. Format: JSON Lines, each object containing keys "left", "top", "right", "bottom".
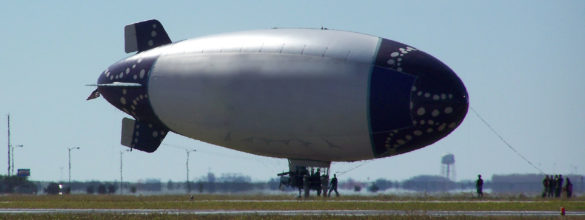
{"left": 121, "top": 118, "right": 168, "bottom": 153}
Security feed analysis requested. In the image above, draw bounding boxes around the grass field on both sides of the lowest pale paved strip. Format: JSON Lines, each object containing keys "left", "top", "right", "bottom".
{"left": 0, "top": 194, "right": 585, "bottom": 219}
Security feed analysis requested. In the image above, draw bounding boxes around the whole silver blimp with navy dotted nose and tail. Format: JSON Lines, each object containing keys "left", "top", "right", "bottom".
{"left": 88, "top": 20, "right": 469, "bottom": 194}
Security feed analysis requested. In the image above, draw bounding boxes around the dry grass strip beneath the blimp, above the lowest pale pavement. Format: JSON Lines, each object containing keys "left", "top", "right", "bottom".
{"left": 0, "top": 195, "right": 585, "bottom": 211}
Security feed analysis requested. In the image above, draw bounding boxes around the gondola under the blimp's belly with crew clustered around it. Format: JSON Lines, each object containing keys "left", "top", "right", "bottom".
{"left": 278, "top": 159, "right": 331, "bottom": 198}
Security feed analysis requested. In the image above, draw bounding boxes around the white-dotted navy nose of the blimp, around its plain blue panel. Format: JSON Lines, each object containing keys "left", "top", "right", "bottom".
{"left": 372, "top": 40, "right": 469, "bottom": 157}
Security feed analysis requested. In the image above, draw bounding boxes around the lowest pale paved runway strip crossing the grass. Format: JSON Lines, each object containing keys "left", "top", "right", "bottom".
{"left": 0, "top": 208, "right": 585, "bottom": 216}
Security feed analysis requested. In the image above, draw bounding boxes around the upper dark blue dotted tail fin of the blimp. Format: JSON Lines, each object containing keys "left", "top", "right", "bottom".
{"left": 124, "top": 19, "right": 171, "bottom": 53}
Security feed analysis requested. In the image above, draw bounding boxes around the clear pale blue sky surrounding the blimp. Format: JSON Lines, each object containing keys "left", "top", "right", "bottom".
{"left": 0, "top": 0, "right": 585, "bottom": 181}
